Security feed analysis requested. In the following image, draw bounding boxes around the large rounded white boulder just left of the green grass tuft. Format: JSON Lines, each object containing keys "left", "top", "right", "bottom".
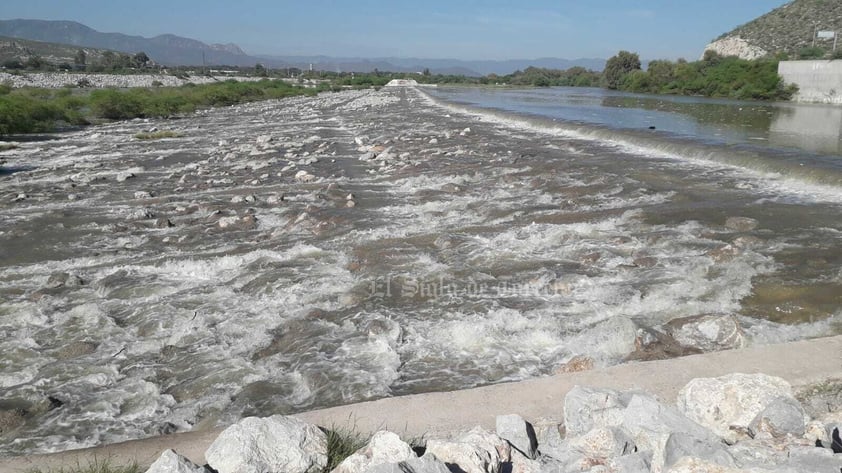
{"left": 205, "top": 415, "right": 327, "bottom": 473}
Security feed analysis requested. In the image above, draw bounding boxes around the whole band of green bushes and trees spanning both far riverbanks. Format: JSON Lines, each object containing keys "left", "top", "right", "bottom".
{"left": 0, "top": 51, "right": 797, "bottom": 136}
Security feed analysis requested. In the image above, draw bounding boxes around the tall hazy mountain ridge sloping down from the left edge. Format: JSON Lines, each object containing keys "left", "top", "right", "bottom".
{"left": 0, "top": 20, "right": 253, "bottom": 66}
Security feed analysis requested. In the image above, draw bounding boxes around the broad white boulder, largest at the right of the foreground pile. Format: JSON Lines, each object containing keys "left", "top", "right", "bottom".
{"left": 677, "top": 373, "right": 806, "bottom": 444}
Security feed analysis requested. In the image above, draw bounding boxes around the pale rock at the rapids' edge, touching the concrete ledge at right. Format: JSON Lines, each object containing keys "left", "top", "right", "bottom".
{"left": 665, "top": 314, "right": 745, "bottom": 351}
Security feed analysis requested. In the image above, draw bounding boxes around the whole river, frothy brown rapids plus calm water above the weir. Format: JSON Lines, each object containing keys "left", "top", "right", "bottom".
{"left": 0, "top": 88, "right": 842, "bottom": 456}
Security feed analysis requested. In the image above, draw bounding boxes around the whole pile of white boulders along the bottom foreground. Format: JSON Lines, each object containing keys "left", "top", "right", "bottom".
{"left": 147, "top": 374, "right": 842, "bottom": 473}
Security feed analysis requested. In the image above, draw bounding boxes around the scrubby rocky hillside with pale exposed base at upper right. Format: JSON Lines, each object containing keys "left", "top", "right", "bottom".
{"left": 705, "top": 0, "right": 842, "bottom": 59}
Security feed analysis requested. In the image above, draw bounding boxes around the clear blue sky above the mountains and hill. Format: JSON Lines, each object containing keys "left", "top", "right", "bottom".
{"left": 0, "top": 0, "right": 786, "bottom": 59}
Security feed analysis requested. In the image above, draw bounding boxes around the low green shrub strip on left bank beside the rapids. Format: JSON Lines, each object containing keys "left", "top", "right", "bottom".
{"left": 0, "top": 80, "right": 319, "bottom": 135}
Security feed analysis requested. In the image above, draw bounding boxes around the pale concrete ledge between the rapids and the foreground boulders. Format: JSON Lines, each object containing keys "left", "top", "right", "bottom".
{"left": 0, "top": 336, "right": 842, "bottom": 473}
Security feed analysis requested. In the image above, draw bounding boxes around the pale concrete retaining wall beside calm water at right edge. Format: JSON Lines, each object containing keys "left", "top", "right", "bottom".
{"left": 778, "top": 61, "right": 842, "bottom": 105}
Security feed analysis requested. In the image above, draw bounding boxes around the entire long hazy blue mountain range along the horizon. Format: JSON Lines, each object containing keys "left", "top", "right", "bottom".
{"left": 0, "top": 19, "right": 605, "bottom": 76}
